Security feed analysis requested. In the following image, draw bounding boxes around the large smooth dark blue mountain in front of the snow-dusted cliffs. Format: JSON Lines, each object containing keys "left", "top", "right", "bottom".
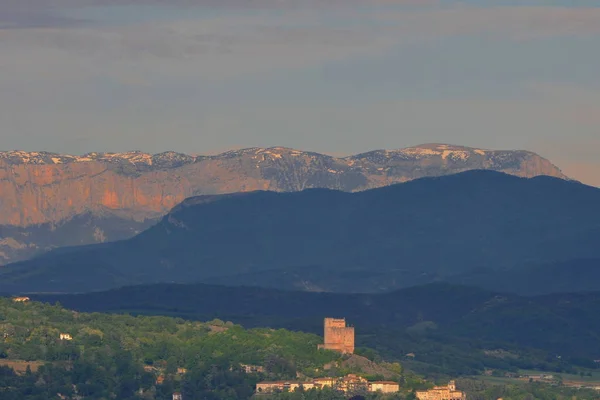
{"left": 0, "top": 171, "right": 600, "bottom": 292}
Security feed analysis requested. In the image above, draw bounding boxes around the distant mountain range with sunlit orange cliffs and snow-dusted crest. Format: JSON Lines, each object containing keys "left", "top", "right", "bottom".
{"left": 0, "top": 144, "right": 566, "bottom": 265}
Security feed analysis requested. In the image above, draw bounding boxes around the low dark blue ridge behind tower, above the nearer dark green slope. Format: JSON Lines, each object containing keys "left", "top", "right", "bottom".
{"left": 30, "top": 283, "right": 600, "bottom": 359}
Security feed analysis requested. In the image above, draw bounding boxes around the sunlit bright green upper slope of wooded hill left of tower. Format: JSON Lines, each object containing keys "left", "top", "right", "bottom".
{"left": 0, "top": 298, "right": 339, "bottom": 368}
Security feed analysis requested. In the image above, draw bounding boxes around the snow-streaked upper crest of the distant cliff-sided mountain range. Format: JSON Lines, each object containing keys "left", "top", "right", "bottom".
{"left": 0, "top": 143, "right": 556, "bottom": 178}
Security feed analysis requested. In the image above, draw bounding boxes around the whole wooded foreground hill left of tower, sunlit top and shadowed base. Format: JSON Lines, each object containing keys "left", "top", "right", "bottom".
{"left": 0, "top": 298, "right": 408, "bottom": 400}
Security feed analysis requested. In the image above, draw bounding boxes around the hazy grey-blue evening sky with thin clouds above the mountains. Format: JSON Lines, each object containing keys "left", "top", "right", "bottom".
{"left": 0, "top": 0, "right": 600, "bottom": 186}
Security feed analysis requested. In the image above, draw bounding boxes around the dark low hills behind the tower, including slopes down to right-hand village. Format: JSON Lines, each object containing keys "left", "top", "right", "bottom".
{"left": 31, "top": 284, "right": 600, "bottom": 374}
